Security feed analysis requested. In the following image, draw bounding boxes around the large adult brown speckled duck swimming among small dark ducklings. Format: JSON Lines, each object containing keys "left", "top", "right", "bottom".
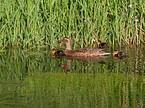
{"left": 59, "top": 38, "right": 111, "bottom": 57}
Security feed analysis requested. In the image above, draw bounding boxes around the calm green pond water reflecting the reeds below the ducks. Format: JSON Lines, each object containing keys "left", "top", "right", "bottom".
{"left": 0, "top": 46, "right": 145, "bottom": 108}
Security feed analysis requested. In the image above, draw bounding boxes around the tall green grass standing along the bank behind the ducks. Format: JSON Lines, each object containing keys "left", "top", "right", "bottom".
{"left": 0, "top": 0, "right": 145, "bottom": 48}
